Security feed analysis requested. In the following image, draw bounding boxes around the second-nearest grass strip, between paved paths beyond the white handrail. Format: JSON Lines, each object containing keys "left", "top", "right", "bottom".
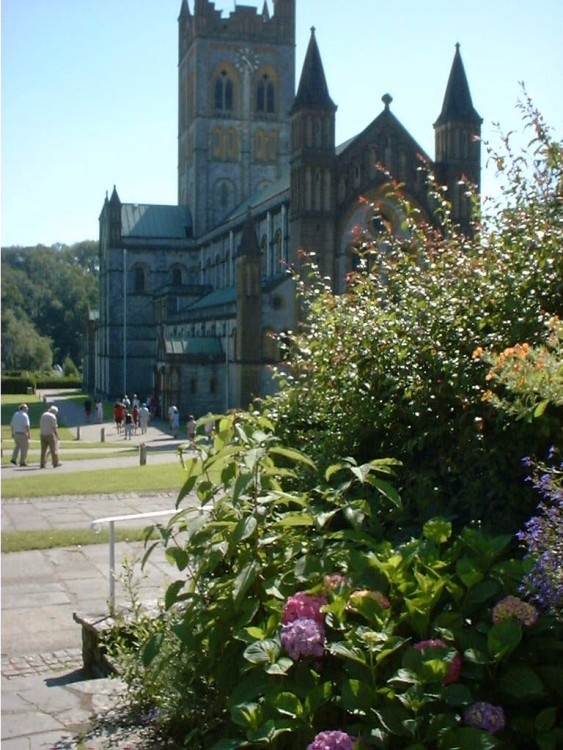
{"left": 2, "top": 462, "right": 186, "bottom": 498}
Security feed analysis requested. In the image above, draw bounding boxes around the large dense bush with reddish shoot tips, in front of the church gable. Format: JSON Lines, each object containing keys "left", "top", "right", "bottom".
{"left": 270, "top": 97, "right": 563, "bottom": 532}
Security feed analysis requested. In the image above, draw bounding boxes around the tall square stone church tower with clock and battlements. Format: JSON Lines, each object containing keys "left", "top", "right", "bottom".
{"left": 178, "top": 0, "right": 295, "bottom": 237}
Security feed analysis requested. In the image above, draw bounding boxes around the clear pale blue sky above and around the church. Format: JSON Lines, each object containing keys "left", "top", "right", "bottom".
{"left": 1, "top": 0, "right": 563, "bottom": 247}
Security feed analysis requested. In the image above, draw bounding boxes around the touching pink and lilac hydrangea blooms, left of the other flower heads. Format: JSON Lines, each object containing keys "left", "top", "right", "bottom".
{"left": 280, "top": 592, "right": 326, "bottom": 661}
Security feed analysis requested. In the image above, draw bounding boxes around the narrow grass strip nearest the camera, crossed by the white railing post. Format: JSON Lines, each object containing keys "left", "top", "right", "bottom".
{"left": 2, "top": 528, "right": 158, "bottom": 553}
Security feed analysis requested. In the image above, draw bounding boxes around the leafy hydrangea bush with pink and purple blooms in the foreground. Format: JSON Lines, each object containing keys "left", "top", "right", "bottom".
{"left": 106, "top": 414, "right": 563, "bottom": 750}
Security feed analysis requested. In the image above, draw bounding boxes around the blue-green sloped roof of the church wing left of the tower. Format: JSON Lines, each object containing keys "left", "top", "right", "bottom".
{"left": 121, "top": 203, "right": 193, "bottom": 239}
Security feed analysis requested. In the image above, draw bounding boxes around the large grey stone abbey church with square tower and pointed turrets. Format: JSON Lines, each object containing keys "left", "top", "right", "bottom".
{"left": 84, "top": 0, "right": 482, "bottom": 418}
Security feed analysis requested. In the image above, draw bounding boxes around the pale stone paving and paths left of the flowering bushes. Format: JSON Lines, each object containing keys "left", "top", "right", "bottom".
{"left": 1, "top": 393, "right": 200, "bottom": 750}
